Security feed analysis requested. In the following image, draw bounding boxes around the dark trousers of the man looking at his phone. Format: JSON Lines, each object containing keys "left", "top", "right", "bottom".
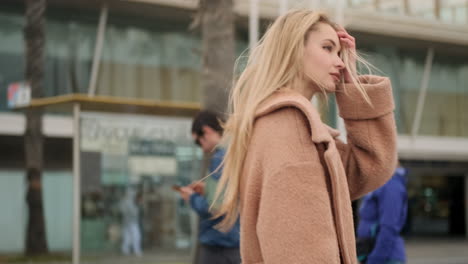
{"left": 197, "top": 245, "right": 241, "bottom": 264}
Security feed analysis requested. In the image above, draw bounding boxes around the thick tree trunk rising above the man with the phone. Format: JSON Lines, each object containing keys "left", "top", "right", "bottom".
{"left": 199, "top": 0, "right": 235, "bottom": 116}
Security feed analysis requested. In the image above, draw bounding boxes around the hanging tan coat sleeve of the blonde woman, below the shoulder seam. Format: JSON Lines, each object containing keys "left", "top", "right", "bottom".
{"left": 257, "top": 162, "right": 340, "bottom": 264}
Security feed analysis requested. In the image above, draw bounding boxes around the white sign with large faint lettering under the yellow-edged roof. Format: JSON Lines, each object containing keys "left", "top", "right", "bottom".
{"left": 80, "top": 112, "right": 193, "bottom": 156}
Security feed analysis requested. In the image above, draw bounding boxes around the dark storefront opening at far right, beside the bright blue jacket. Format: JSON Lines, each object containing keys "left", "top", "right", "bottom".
{"left": 402, "top": 160, "right": 468, "bottom": 238}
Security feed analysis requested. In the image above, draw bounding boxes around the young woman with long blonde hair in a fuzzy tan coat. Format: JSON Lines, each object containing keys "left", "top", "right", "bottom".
{"left": 214, "top": 10, "right": 396, "bottom": 264}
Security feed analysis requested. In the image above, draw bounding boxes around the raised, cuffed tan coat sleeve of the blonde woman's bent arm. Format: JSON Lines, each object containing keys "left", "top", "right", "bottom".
{"left": 336, "top": 76, "right": 397, "bottom": 200}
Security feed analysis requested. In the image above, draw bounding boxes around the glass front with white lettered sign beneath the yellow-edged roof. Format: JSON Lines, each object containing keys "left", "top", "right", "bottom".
{"left": 80, "top": 112, "right": 202, "bottom": 253}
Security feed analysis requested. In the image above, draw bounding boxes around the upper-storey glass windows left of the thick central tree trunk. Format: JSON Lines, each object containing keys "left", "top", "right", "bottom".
{"left": 0, "top": 9, "right": 201, "bottom": 110}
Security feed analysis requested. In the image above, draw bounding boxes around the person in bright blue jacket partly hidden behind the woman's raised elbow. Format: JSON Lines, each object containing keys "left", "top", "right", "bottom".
{"left": 357, "top": 166, "right": 408, "bottom": 264}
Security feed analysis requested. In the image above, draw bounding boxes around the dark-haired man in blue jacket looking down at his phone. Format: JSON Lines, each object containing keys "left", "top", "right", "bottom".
{"left": 180, "top": 111, "right": 241, "bottom": 264}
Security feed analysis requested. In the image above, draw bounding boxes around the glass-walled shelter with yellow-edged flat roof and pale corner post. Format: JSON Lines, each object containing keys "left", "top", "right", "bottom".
{"left": 18, "top": 94, "right": 203, "bottom": 264}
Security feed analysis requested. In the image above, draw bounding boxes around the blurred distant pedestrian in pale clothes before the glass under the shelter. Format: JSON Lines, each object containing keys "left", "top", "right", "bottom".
{"left": 120, "top": 188, "right": 142, "bottom": 256}
